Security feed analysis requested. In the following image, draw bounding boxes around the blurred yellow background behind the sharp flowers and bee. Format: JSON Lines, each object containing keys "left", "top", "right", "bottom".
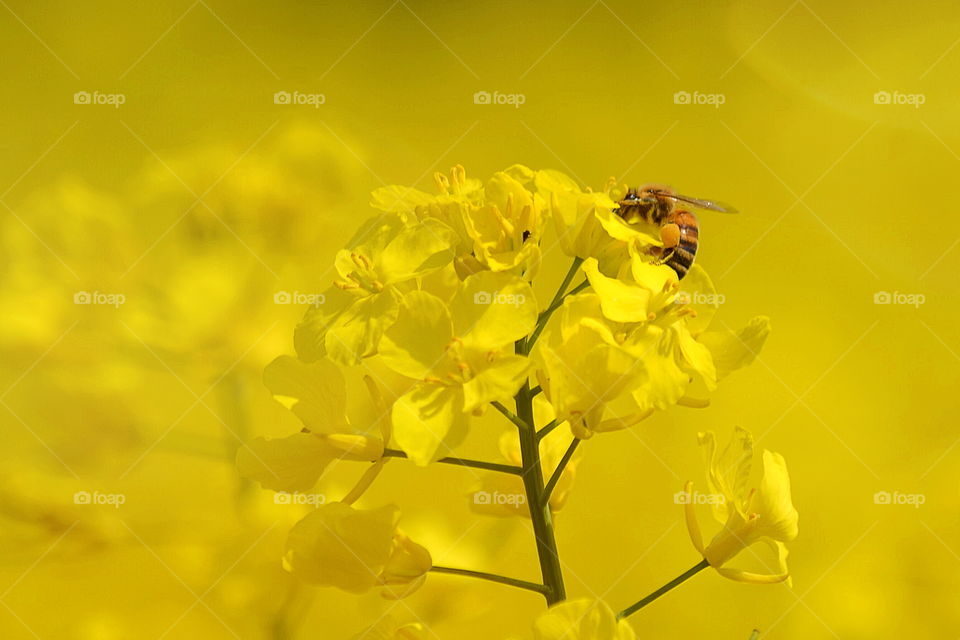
{"left": 0, "top": 0, "right": 960, "bottom": 640}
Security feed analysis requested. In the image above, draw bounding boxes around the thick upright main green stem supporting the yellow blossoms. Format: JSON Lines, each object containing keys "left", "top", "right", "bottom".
{"left": 516, "top": 380, "right": 567, "bottom": 605}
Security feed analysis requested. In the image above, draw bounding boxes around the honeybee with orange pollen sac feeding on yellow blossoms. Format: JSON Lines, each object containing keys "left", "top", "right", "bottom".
{"left": 616, "top": 184, "right": 737, "bottom": 279}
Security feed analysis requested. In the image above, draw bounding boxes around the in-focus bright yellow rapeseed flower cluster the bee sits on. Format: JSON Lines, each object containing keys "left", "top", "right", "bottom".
{"left": 238, "top": 165, "right": 796, "bottom": 640}
